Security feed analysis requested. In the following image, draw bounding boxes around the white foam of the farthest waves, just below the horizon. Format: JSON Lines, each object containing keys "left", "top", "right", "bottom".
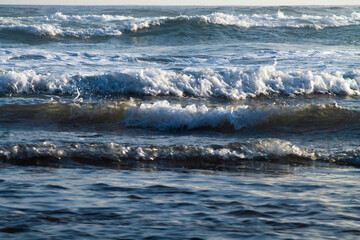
{"left": 0, "top": 10, "right": 360, "bottom": 37}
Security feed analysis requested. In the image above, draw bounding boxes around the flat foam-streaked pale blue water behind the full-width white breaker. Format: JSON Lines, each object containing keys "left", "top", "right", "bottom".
{"left": 0, "top": 48, "right": 360, "bottom": 75}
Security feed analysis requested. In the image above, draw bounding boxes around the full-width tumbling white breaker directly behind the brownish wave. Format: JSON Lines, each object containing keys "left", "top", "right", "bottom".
{"left": 0, "top": 65, "right": 360, "bottom": 100}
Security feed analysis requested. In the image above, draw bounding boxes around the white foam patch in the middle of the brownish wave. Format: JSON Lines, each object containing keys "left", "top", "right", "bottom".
{"left": 124, "top": 101, "right": 281, "bottom": 130}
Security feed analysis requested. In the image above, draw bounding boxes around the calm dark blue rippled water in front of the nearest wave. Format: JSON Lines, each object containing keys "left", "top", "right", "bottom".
{"left": 0, "top": 164, "right": 360, "bottom": 239}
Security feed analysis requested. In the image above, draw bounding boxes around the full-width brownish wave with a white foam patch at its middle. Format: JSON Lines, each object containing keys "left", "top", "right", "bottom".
{"left": 0, "top": 99, "right": 360, "bottom": 131}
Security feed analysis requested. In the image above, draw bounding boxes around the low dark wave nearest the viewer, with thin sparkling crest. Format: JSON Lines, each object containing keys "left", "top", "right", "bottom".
{"left": 0, "top": 139, "right": 359, "bottom": 169}
